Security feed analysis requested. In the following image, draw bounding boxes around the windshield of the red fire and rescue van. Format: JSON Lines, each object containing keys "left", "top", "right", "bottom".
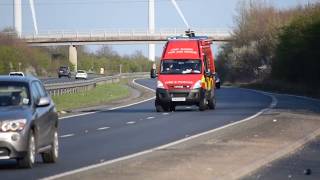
{"left": 160, "top": 59, "right": 201, "bottom": 74}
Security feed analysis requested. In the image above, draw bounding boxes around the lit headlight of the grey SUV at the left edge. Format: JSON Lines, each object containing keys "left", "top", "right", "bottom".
{"left": 0, "top": 119, "right": 27, "bottom": 132}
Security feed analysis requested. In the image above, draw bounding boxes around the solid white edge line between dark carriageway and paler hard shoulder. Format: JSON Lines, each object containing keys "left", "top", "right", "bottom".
{"left": 43, "top": 88, "right": 278, "bottom": 180}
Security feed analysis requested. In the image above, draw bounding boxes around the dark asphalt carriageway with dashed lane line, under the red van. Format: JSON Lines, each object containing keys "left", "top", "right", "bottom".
{"left": 0, "top": 80, "right": 271, "bottom": 179}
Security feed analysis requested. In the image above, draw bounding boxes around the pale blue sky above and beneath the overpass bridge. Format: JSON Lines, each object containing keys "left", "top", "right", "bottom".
{"left": 0, "top": 0, "right": 320, "bottom": 56}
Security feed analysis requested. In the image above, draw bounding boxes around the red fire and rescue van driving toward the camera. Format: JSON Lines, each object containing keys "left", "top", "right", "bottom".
{"left": 155, "top": 33, "right": 216, "bottom": 112}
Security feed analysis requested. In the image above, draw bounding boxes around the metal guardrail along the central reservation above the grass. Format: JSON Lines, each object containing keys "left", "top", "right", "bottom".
{"left": 44, "top": 72, "right": 149, "bottom": 96}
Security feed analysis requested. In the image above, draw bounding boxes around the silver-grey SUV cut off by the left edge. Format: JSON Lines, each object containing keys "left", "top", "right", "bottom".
{"left": 0, "top": 76, "right": 59, "bottom": 168}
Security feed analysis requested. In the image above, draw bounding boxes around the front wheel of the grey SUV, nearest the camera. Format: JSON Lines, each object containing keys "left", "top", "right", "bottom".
{"left": 18, "top": 131, "right": 36, "bottom": 168}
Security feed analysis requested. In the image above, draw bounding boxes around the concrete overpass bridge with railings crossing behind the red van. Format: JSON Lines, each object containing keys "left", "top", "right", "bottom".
{"left": 21, "top": 28, "right": 231, "bottom": 46}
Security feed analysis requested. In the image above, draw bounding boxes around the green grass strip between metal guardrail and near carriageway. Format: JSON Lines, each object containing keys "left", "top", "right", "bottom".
{"left": 52, "top": 82, "right": 130, "bottom": 111}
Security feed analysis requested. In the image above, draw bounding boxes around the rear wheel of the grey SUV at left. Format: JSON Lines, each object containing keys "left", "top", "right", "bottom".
{"left": 41, "top": 130, "right": 59, "bottom": 163}
